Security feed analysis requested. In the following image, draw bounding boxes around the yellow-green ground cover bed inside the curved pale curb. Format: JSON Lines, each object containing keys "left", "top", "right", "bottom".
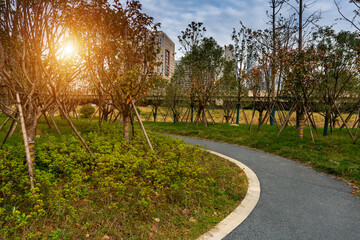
{"left": 0, "top": 116, "right": 247, "bottom": 239}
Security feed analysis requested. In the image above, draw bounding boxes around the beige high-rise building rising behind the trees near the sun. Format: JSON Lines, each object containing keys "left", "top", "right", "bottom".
{"left": 156, "top": 31, "right": 175, "bottom": 80}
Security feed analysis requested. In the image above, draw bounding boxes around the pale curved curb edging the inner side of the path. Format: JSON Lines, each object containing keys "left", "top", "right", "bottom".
{"left": 197, "top": 150, "right": 260, "bottom": 240}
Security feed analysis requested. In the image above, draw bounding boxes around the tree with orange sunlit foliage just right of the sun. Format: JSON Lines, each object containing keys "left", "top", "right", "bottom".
{"left": 76, "top": 0, "right": 159, "bottom": 142}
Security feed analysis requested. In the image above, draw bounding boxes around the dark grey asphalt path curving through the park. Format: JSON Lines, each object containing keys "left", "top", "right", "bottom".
{"left": 179, "top": 138, "right": 360, "bottom": 240}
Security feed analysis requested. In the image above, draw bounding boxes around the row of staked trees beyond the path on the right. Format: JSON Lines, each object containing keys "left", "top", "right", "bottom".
{"left": 168, "top": 0, "right": 360, "bottom": 142}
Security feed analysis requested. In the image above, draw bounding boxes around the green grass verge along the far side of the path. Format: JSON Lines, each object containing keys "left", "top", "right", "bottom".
{"left": 145, "top": 122, "right": 360, "bottom": 195}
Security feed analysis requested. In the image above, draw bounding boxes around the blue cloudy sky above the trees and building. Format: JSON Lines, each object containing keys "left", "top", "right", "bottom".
{"left": 136, "top": 0, "right": 355, "bottom": 59}
